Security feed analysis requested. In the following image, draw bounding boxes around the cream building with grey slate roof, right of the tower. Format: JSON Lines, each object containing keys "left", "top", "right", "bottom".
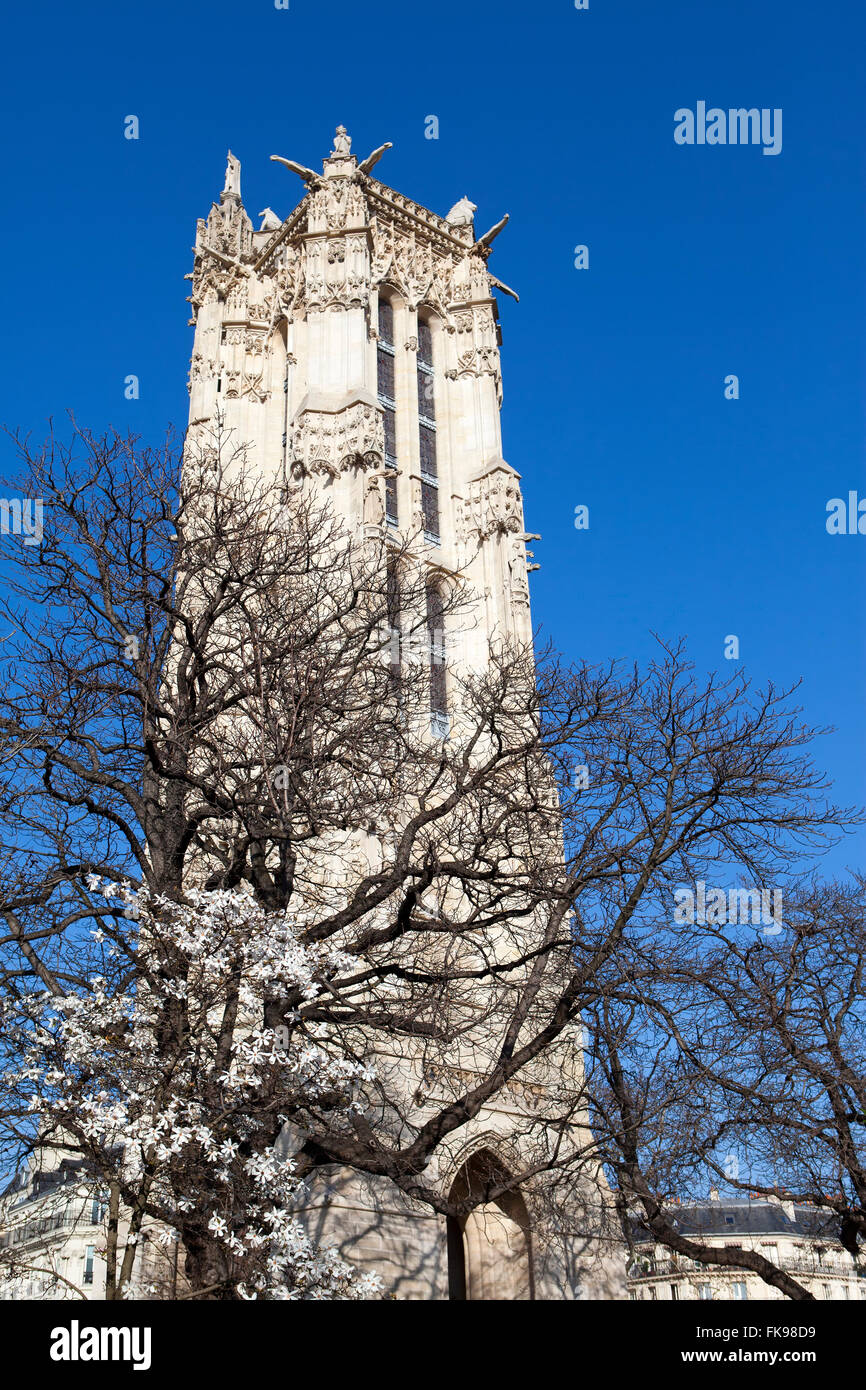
{"left": 628, "top": 1197, "right": 866, "bottom": 1301}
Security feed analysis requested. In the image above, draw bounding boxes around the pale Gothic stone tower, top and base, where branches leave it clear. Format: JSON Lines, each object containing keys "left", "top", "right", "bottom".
{"left": 189, "top": 126, "right": 616, "bottom": 1298}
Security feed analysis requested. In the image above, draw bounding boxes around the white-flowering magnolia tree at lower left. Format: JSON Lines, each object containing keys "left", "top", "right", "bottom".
{"left": 0, "top": 876, "right": 378, "bottom": 1298}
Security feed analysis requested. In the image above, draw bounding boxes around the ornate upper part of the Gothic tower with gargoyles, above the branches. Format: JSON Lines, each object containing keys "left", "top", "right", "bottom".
{"left": 189, "top": 126, "right": 532, "bottom": 678}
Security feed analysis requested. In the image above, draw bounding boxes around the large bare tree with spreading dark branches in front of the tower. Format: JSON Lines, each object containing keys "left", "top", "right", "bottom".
{"left": 0, "top": 419, "right": 856, "bottom": 1297}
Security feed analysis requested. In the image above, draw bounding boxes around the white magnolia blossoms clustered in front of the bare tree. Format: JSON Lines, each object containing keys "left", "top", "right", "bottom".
{"left": 0, "top": 874, "right": 381, "bottom": 1300}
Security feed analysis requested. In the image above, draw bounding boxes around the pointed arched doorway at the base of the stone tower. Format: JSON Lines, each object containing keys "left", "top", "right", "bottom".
{"left": 448, "top": 1148, "right": 534, "bottom": 1301}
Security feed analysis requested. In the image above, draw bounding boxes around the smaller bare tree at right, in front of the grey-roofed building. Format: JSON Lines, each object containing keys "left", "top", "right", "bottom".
{"left": 587, "top": 878, "right": 866, "bottom": 1298}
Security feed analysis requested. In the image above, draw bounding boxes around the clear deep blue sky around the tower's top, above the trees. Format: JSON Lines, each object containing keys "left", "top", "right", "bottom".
{"left": 0, "top": 0, "right": 866, "bottom": 866}
